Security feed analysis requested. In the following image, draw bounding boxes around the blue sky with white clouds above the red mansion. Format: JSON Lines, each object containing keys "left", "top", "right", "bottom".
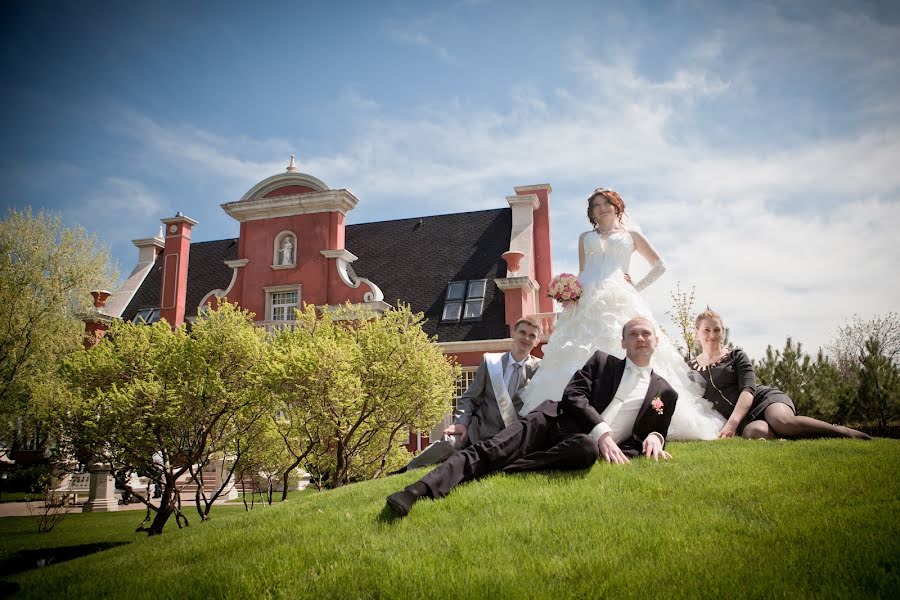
{"left": 0, "top": 0, "right": 900, "bottom": 356}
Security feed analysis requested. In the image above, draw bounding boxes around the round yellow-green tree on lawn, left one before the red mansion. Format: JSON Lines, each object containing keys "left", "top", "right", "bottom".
{"left": 61, "top": 303, "right": 268, "bottom": 535}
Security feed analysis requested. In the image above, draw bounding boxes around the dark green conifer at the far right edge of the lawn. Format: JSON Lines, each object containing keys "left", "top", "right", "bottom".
{"left": 857, "top": 337, "right": 900, "bottom": 432}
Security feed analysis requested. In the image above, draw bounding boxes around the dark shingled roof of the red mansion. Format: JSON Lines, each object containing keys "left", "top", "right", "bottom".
{"left": 122, "top": 208, "right": 512, "bottom": 342}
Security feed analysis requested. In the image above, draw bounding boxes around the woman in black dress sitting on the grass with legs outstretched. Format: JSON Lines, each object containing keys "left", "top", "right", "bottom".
{"left": 691, "top": 309, "right": 870, "bottom": 439}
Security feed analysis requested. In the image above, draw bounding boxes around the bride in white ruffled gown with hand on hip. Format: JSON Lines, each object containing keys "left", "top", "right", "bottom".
{"left": 520, "top": 188, "right": 724, "bottom": 440}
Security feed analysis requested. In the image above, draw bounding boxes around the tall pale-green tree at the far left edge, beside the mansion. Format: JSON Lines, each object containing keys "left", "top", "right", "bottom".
{"left": 0, "top": 209, "right": 117, "bottom": 450}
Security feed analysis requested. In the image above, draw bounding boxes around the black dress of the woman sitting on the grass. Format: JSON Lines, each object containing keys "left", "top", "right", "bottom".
{"left": 691, "top": 348, "right": 797, "bottom": 433}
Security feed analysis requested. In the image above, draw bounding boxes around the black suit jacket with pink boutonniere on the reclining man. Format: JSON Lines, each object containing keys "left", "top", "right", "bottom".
{"left": 535, "top": 351, "right": 678, "bottom": 456}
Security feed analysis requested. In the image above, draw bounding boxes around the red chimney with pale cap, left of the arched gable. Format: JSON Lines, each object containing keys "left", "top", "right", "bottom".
{"left": 159, "top": 212, "right": 197, "bottom": 329}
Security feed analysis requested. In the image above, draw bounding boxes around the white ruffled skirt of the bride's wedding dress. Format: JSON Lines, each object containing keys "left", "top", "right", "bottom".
{"left": 522, "top": 271, "right": 725, "bottom": 440}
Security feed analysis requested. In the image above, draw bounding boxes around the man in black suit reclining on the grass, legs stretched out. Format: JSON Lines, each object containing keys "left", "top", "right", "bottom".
{"left": 387, "top": 317, "right": 678, "bottom": 516}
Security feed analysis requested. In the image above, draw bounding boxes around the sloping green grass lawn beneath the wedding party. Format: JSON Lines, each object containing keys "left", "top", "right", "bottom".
{"left": 0, "top": 439, "right": 900, "bottom": 598}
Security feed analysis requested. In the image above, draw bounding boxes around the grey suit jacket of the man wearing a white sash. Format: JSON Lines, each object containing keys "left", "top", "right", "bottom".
{"left": 453, "top": 352, "right": 541, "bottom": 445}
